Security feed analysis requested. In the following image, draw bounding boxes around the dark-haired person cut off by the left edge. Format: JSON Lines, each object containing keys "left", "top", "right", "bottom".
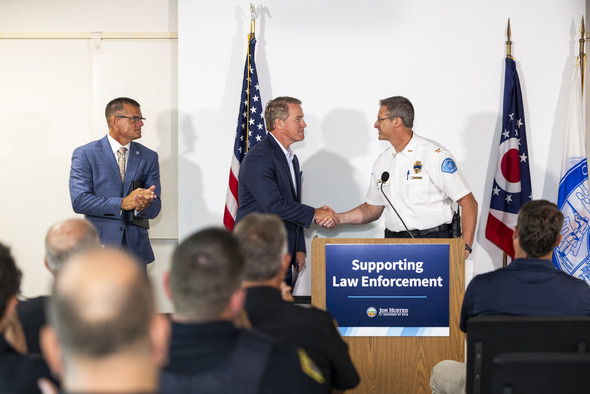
{"left": 0, "top": 244, "right": 57, "bottom": 393}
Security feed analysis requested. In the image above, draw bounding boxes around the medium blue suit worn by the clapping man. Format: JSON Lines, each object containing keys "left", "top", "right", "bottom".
{"left": 70, "top": 136, "right": 162, "bottom": 263}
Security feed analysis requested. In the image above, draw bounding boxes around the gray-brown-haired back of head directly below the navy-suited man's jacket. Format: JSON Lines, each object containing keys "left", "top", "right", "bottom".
{"left": 234, "top": 213, "right": 287, "bottom": 282}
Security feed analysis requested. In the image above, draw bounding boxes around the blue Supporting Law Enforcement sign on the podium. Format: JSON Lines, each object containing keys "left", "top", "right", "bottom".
{"left": 325, "top": 244, "right": 449, "bottom": 336}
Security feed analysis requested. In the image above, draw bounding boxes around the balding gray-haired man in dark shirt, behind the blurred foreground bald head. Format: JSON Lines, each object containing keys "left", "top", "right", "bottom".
{"left": 16, "top": 218, "right": 100, "bottom": 354}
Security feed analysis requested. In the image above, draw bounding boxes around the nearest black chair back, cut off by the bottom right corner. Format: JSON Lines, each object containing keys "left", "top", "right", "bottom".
{"left": 492, "top": 353, "right": 590, "bottom": 394}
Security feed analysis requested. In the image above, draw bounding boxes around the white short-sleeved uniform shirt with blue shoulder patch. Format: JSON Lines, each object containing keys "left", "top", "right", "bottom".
{"left": 365, "top": 133, "right": 471, "bottom": 232}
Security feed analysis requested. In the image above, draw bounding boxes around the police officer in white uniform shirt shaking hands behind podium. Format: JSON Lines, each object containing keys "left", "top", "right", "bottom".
{"left": 330, "top": 96, "right": 477, "bottom": 258}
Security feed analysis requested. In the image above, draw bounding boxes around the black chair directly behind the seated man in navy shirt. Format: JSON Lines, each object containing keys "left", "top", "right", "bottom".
{"left": 466, "top": 315, "right": 590, "bottom": 394}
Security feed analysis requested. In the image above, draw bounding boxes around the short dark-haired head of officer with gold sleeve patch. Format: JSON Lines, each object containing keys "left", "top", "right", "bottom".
{"left": 170, "top": 228, "right": 244, "bottom": 321}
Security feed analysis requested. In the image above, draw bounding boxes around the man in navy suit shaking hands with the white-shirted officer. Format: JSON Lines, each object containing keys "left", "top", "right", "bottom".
{"left": 236, "top": 97, "right": 335, "bottom": 285}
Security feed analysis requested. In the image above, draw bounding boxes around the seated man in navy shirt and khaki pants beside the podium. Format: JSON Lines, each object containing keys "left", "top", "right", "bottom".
{"left": 430, "top": 200, "right": 590, "bottom": 393}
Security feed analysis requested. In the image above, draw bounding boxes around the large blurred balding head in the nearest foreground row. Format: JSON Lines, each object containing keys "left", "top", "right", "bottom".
{"left": 47, "top": 249, "right": 155, "bottom": 359}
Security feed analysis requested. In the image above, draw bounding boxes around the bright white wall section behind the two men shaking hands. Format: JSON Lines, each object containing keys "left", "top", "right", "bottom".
{"left": 178, "top": 0, "right": 585, "bottom": 292}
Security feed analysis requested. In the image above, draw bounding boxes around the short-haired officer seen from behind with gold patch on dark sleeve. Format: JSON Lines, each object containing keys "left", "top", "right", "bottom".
{"left": 161, "top": 228, "right": 323, "bottom": 394}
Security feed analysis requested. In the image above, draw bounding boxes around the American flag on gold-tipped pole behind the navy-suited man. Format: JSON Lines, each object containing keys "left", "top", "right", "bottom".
{"left": 223, "top": 34, "right": 266, "bottom": 232}
